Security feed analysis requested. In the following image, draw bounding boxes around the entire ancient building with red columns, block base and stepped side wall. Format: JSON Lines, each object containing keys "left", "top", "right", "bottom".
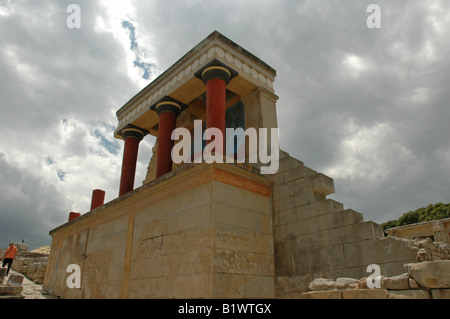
{"left": 44, "top": 32, "right": 448, "bottom": 298}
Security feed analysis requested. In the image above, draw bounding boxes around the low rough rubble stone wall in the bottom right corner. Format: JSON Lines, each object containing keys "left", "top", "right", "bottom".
{"left": 301, "top": 260, "right": 450, "bottom": 299}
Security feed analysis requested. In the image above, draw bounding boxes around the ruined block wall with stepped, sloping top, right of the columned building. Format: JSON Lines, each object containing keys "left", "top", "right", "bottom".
{"left": 270, "top": 150, "right": 417, "bottom": 297}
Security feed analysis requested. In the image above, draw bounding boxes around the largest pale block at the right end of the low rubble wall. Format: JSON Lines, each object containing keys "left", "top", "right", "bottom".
{"left": 405, "top": 260, "right": 450, "bottom": 288}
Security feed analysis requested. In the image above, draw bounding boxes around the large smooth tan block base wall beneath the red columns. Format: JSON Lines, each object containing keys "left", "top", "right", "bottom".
{"left": 44, "top": 164, "right": 274, "bottom": 299}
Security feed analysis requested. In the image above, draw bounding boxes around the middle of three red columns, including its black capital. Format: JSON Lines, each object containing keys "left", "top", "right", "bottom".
{"left": 150, "top": 96, "right": 187, "bottom": 178}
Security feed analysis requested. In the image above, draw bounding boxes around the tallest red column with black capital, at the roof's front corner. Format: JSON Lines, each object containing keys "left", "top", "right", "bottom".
{"left": 195, "top": 60, "right": 238, "bottom": 153}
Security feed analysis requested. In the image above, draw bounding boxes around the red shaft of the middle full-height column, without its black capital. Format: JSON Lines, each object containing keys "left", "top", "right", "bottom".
{"left": 156, "top": 112, "right": 177, "bottom": 178}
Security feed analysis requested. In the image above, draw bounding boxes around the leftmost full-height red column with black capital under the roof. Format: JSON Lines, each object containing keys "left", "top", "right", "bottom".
{"left": 119, "top": 125, "right": 147, "bottom": 196}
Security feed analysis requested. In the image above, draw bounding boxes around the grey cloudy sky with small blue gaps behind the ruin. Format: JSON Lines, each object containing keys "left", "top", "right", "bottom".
{"left": 0, "top": 0, "right": 450, "bottom": 248}
